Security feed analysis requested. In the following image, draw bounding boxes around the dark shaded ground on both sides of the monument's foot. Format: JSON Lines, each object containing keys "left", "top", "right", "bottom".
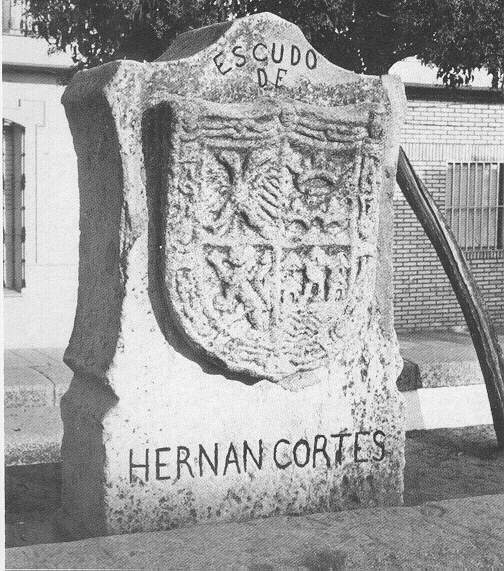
{"left": 5, "top": 426, "right": 504, "bottom": 548}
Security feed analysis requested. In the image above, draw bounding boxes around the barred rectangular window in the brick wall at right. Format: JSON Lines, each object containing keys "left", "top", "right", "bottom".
{"left": 446, "top": 162, "right": 504, "bottom": 251}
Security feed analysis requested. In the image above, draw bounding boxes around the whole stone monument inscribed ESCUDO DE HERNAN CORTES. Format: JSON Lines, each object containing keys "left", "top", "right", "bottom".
{"left": 61, "top": 13, "right": 405, "bottom": 537}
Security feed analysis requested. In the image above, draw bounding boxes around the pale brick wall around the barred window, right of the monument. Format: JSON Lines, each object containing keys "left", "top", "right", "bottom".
{"left": 394, "top": 100, "right": 504, "bottom": 329}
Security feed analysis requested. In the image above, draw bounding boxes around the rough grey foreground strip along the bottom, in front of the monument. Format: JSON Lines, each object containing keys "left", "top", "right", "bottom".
{"left": 5, "top": 495, "right": 504, "bottom": 569}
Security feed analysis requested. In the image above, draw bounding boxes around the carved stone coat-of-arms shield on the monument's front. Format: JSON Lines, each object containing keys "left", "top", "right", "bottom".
{"left": 161, "top": 98, "right": 382, "bottom": 381}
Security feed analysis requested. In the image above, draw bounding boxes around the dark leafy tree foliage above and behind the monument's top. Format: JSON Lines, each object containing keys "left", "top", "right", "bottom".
{"left": 29, "top": 0, "right": 504, "bottom": 87}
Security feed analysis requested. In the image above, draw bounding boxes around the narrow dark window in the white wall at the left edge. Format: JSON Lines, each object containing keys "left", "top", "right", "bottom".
{"left": 2, "top": 120, "right": 25, "bottom": 291}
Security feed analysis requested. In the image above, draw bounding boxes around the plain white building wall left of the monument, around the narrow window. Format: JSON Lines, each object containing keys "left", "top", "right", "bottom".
{"left": 3, "top": 69, "right": 79, "bottom": 348}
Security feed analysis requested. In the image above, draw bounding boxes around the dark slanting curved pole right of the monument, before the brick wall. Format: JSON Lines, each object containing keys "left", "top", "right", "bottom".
{"left": 397, "top": 147, "right": 504, "bottom": 448}
